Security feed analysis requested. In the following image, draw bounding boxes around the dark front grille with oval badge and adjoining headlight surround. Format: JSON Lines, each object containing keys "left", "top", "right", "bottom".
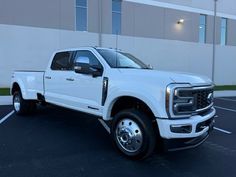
{"left": 166, "top": 83, "right": 214, "bottom": 118}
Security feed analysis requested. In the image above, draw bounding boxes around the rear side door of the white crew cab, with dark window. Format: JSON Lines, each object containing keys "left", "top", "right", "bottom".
{"left": 44, "top": 51, "right": 74, "bottom": 106}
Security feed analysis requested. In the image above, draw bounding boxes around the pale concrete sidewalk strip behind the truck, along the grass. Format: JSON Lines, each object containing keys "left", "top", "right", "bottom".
{"left": 0, "top": 91, "right": 236, "bottom": 105}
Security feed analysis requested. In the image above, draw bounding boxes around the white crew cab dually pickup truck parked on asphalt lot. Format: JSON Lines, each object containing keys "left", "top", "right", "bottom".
{"left": 11, "top": 47, "right": 216, "bottom": 159}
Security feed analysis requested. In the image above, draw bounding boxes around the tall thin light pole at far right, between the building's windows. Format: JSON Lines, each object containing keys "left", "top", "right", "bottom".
{"left": 212, "top": 0, "right": 218, "bottom": 82}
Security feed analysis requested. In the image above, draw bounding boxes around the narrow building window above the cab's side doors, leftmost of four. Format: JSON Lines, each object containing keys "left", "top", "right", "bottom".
{"left": 76, "top": 0, "right": 87, "bottom": 31}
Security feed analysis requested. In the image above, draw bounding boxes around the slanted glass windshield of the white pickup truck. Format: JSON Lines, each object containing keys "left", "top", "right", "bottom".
{"left": 97, "top": 49, "right": 148, "bottom": 69}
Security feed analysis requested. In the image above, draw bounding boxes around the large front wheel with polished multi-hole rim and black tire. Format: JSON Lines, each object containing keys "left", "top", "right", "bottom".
{"left": 111, "top": 109, "right": 157, "bottom": 159}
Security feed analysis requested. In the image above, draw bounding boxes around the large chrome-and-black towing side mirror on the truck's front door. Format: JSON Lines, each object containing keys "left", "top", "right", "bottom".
{"left": 74, "top": 57, "right": 103, "bottom": 77}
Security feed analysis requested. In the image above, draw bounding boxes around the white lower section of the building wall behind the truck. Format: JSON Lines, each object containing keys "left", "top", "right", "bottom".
{"left": 0, "top": 25, "right": 236, "bottom": 87}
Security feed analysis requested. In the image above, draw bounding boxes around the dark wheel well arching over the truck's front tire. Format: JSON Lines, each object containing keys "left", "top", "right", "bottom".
{"left": 111, "top": 96, "right": 155, "bottom": 120}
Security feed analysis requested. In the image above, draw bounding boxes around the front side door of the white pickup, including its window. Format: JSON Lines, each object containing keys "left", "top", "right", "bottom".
{"left": 70, "top": 50, "right": 103, "bottom": 115}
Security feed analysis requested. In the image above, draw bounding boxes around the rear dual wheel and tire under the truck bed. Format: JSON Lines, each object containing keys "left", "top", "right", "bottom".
{"left": 13, "top": 91, "right": 36, "bottom": 115}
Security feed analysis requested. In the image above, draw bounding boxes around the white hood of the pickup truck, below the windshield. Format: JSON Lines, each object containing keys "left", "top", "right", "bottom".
{"left": 119, "top": 69, "right": 212, "bottom": 86}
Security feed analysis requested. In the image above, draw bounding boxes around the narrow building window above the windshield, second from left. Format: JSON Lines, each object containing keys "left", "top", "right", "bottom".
{"left": 112, "top": 0, "right": 121, "bottom": 34}
